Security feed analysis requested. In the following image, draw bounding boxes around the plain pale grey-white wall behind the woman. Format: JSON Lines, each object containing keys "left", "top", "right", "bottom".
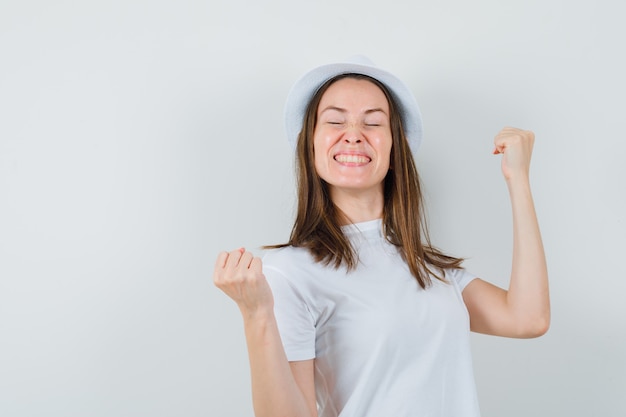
{"left": 0, "top": 0, "right": 626, "bottom": 417}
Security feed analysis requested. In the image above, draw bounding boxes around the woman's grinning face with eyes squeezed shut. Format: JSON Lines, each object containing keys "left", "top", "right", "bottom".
{"left": 313, "top": 78, "right": 392, "bottom": 199}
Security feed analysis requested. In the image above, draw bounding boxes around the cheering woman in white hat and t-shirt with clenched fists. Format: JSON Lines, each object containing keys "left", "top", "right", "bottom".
{"left": 214, "top": 58, "right": 550, "bottom": 417}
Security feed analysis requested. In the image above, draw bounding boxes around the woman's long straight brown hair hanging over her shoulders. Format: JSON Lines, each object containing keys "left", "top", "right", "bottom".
{"left": 266, "top": 74, "right": 463, "bottom": 288}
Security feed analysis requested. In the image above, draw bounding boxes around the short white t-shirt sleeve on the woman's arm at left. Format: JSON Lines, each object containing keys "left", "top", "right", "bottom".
{"left": 263, "top": 267, "right": 315, "bottom": 361}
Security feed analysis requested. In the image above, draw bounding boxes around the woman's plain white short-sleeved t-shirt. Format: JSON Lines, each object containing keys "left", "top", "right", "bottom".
{"left": 263, "top": 220, "right": 480, "bottom": 417}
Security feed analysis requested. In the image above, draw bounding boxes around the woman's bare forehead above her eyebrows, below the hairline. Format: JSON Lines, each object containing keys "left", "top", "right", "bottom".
{"left": 318, "top": 77, "right": 389, "bottom": 111}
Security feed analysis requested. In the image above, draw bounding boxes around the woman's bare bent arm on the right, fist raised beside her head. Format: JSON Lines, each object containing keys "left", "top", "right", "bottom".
{"left": 463, "top": 127, "right": 550, "bottom": 338}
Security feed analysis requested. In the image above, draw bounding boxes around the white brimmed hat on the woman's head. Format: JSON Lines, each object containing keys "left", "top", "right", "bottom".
{"left": 285, "top": 55, "right": 422, "bottom": 154}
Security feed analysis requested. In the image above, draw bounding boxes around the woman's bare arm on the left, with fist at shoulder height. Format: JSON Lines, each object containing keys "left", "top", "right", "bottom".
{"left": 213, "top": 249, "right": 317, "bottom": 417}
